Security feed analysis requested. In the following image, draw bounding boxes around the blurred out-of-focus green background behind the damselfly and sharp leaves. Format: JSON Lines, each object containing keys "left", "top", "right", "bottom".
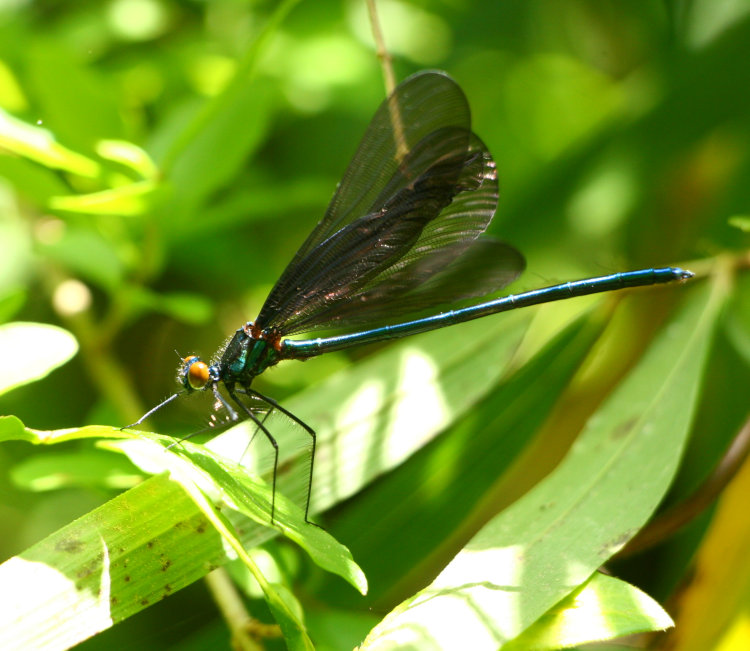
{"left": 0, "top": 0, "right": 750, "bottom": 648}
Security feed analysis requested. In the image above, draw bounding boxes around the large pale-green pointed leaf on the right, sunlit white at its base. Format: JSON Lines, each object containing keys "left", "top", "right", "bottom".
{"left": 364, "top": 282, "right": 726, "bottom": 650}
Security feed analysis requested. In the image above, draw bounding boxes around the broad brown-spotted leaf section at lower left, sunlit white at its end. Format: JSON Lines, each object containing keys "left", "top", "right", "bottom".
{"left": 0, "top": 476, "right": 227, "bottom": 649}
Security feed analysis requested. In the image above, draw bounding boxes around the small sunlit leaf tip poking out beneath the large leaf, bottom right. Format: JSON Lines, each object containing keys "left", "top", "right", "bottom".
{"left": 503, "top": 572, "right": 674, "bottom": 651}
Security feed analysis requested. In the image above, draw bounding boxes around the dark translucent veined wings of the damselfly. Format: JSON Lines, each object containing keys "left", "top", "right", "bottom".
{"left": 256, "top": 72, "right": 524, "bottom": 335}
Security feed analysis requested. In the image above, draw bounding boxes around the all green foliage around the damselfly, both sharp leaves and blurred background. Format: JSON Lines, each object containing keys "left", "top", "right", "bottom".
{"left": 0, "top": 0, "right": 750, "bottom": 649}
